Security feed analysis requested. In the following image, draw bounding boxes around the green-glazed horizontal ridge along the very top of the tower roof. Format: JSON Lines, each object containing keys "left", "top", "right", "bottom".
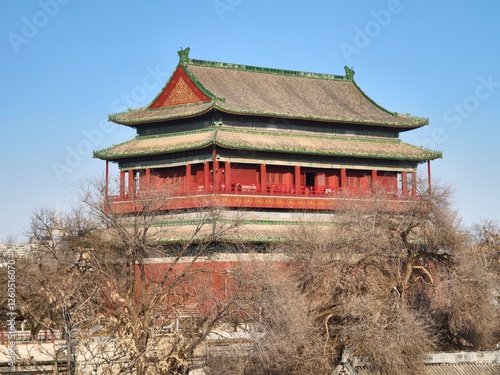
{"left": 182, "top": 59, "right": 352, "bottom": 81}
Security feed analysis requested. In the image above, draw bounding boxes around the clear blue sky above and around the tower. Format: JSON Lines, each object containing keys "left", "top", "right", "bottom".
{"left": 0, "top": 0, "right": 500, "bottom": 240}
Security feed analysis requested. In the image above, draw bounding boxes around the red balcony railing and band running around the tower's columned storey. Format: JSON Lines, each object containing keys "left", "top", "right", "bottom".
{"left": 104, "top": 184, "right": 417, "bottom": 213}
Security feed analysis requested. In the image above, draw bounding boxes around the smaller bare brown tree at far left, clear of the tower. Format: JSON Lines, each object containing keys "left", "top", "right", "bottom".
{"left": 5, "top": 208, "right": 98, "bottom": 374}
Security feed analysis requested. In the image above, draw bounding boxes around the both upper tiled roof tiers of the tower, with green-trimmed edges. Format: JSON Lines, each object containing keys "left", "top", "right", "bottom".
{"left": 94, "top": 49, "right": 441, "bottom": 162}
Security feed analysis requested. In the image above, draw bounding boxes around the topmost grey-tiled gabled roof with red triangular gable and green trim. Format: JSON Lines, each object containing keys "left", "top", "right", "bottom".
{"left": 109, "top": 48, "right": 428, "bottom": 130}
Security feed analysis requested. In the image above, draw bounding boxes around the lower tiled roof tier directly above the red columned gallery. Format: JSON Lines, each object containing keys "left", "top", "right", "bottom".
{"left": 94, "top": 127, "right": 442, "bottom": 162}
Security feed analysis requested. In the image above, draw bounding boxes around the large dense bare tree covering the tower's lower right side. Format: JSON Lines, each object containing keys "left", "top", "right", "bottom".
{"left": 232, "top": 183, "right": 498, "bottom": 375}
